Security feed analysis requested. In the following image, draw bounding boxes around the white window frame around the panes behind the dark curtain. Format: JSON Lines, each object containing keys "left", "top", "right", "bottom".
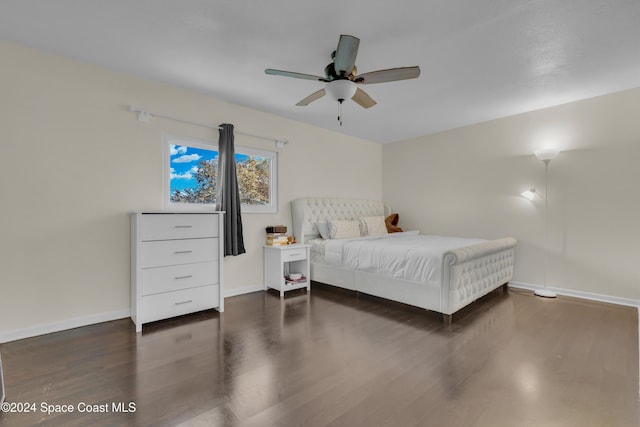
{"left": 162, "top": 133, "right": 278, "bottom": 213}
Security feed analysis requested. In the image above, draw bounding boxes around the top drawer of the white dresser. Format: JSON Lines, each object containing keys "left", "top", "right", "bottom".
{"left": 138, "top": 214, "right": 219, "bottom": 241}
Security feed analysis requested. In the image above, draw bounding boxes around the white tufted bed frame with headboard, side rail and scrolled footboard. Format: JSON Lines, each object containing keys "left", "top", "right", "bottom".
{"left": 291, "top": 197, "right": 516, "bottom": 324}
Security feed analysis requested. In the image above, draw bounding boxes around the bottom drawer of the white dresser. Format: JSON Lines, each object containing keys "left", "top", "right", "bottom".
{"left": 138, "top": 285, "right": 220, "bottom": 323}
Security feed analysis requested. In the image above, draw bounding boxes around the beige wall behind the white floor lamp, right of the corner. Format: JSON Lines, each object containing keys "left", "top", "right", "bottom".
{"left": 383, "top": 89, "right": 640, "bottom": 303}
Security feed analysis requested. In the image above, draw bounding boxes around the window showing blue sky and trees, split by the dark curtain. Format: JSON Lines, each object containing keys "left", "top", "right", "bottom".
{"left": 163, "top": 135, "right": 278, "bottom": 212}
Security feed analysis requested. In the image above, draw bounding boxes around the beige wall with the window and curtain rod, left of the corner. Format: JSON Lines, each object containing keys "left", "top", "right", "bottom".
{"left": 0, "top": 41, "right": 382, "bottom": 342}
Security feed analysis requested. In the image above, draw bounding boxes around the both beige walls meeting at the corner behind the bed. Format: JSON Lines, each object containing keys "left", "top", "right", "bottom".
{"left": 0, "top": 42, "right": 640, "bottom": 342}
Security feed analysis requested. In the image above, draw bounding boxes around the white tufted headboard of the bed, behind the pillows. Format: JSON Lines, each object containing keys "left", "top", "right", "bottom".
{"left": 291, "top": 197, "right": 391, "bottom": 243}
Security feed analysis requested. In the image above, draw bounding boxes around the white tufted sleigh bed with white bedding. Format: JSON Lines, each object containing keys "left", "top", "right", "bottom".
{"left": 291, "top": 197, "right": 516, "bottom": 324}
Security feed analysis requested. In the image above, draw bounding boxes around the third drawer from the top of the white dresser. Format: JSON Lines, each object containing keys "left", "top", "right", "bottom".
{"left": 139, "top": 261, "right": 220, "bottom": 295}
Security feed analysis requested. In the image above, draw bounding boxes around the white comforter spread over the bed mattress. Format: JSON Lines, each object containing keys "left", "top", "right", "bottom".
{"left": 325, "top": 231, "right": 486, "bottom": 286}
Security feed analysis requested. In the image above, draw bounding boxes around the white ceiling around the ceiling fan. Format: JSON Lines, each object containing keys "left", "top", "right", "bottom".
{"left": 0, "top": 0, "right": 640, "bottom": 143}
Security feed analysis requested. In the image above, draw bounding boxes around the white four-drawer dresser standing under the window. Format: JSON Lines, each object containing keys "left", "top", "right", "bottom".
{"left": 131, "top": 212, "right": 224, "bottom": 332}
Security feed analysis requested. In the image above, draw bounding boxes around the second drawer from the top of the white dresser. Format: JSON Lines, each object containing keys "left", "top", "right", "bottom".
{"left": 138, "top": 238, "right": 218, "bottom": 268}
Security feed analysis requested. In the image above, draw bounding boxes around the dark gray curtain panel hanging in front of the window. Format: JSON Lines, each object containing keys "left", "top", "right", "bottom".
{"left": 216, "top": 123, "right": 245, "bottom": 256}
